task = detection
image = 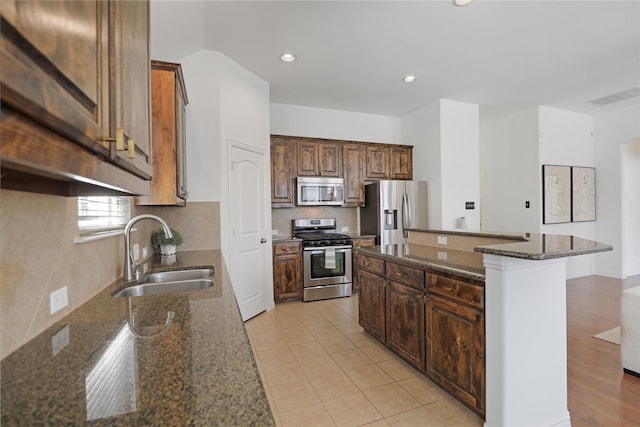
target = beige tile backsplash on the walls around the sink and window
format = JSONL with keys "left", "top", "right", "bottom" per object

{"left": 0, "top": 190, "right": 220, "bottom": 359}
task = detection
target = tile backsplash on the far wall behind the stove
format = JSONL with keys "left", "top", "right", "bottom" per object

{"left": 271, "top": 206, "right": 358, "bottom": 235}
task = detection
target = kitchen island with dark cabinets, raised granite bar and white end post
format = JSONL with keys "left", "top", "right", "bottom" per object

{"left": 359, "top": 230, "right": 612, "bottom": 426}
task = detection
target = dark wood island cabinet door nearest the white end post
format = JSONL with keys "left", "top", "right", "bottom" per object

{"left": 425, "top": 296, "right": 485, "bottom": 413}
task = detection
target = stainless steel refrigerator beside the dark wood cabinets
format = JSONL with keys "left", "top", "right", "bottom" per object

{"left": 360, "top": 181, "right": 427, "bottom": 245}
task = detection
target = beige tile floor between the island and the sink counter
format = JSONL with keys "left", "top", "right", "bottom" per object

{"left": 246, "top": 295, "right": 482, "bottom": 427}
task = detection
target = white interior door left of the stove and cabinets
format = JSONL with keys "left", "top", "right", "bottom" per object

{"left": 229, "top": 144, "right": 270, "bottom": 320}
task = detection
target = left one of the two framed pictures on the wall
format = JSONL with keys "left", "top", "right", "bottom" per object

{"left": 542, "top": 165, "right": 572, "bottom": 224}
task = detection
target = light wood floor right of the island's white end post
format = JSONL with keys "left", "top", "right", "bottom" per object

{"left": 567, "top": 275, "right": 640, "bottom": 427}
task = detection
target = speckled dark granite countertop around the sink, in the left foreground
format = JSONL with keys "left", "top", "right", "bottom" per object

{"left": 1, "top": 250, "right": 274, "bottom": 426}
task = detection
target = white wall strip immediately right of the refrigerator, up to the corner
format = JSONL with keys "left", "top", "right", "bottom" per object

{"left": 402, "top": 103, "right": 442, "bottom": 228}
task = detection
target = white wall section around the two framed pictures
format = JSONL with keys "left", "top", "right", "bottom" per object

{"left": 538, "top": 107, "right": 596, "bottom": 278}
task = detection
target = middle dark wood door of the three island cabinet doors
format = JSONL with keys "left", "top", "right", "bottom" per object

{"left": 386, "top": 282, "right": 425, "bottom": 370}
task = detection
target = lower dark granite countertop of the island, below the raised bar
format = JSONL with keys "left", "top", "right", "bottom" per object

{"left": 358, "top": 244, "right": 485, "bottom": 282}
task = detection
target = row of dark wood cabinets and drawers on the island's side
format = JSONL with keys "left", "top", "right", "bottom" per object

{"left": 358, "top": 252, "right": 485, "bottom": 416}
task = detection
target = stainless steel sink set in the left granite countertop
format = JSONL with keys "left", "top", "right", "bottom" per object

{"left": 111, "top": 267, "right": 213, "bottom": 297}
